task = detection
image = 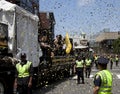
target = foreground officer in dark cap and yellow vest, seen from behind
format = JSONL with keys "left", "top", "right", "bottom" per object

{"left": 93, "top": 57, "right": 113, "bottom": 94}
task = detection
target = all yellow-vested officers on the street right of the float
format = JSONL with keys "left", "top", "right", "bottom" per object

{"left": 74, "top": 54, "right": 120, "bottom": 94}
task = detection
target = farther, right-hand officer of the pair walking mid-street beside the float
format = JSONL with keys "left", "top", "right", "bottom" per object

{"left": 85, "top": 56, "right": 92, "bottom": 78}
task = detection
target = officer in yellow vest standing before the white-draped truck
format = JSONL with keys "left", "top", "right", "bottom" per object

{"left": 14, "top": 53, "right": 33, "bottom": 94}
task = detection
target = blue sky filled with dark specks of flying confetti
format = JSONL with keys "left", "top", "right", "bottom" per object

{"left": 40, "top": 0, "right": 120, "bottom": 35}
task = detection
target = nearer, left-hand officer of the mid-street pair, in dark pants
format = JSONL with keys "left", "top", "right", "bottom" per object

{"left": 75, "top": 57, "right": 84, "bottom": 84}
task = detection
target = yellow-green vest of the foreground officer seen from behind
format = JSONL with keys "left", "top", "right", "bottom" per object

{"left": 96, "top": 70, "right": 112, "bottom": 94}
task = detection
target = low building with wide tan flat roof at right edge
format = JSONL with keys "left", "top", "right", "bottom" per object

{"left": 95, "top": 32, "right": 120, "bottom": 53}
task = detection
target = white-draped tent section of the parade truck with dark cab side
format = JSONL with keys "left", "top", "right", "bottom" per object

{"left": 0, "top": 0, "right": 40, "bottom": 94}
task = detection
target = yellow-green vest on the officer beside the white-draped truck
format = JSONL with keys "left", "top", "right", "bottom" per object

{"left": 16, "top": 61, "right": 32, "bottom": 78}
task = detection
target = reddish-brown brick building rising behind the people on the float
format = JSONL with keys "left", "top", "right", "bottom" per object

{"left": 39, "top": 12, "right": 55, "bottom": 41}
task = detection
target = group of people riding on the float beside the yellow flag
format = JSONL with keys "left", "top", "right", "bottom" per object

{"left": 39, "top": 35, "right": 66, "bottom": 63}
